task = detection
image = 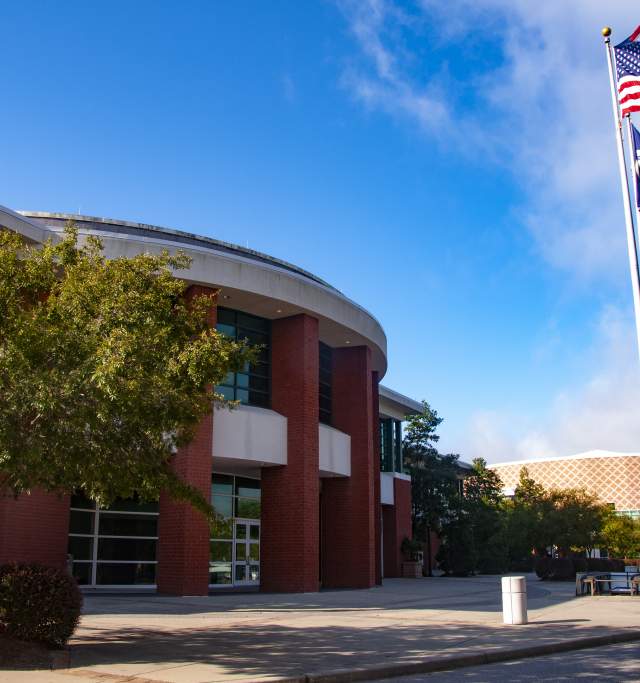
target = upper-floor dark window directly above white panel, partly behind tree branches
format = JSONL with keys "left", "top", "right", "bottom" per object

{"left": 216, "top": 307, "right": 271, "bottom": 407}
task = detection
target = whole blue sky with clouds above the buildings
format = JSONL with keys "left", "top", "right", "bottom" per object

{"left": 0, "top": 0, "right": 640, "bottom": 461}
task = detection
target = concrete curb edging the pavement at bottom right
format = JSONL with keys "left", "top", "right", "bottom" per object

{"left": 296, "top": 631, "right": 640, "bottom": 683}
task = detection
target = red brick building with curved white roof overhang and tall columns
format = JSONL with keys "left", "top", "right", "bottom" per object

{"left": 0, "top": 207, "right": 421, "bottom": 595}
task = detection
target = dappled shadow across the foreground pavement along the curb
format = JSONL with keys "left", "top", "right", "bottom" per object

{"left": 65, "top": 622, "right": 632, "bottom": 680}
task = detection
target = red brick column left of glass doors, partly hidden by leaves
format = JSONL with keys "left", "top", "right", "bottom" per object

{"left": 157, "top": 285, "right": 216, "bottom": 595}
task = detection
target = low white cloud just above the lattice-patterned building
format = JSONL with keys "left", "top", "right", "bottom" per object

{"left": 462, "top": 309, "right": 640, "bottom": 462}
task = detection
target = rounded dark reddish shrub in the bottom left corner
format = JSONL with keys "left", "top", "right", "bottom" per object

{"left": 0, "top": 564, "right": 82, "bottom": 647}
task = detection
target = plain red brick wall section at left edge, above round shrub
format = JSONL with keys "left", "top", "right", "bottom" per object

{"left": 0, "top": 490, "right": 69, "bottom": 569}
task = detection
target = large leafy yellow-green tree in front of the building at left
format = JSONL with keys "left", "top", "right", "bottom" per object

{"left": 0, "top": 225, "right": 253, "bottom": 516}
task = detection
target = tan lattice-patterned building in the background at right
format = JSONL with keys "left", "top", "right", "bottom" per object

{"left": 491, "top": 450, "right": 640, "bottom": 517}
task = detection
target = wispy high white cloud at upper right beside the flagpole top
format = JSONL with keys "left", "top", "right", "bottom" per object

{"left": 338, "top": 0, "right": 639, "bottom": 280}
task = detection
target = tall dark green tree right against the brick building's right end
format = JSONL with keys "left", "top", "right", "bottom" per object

{"left": 403, "top": 401, "right": 459, "bottom": 576}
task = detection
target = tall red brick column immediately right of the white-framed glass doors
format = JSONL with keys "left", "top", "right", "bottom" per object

{"left": 260, "top": 315, "right": 319, "bottom": 592}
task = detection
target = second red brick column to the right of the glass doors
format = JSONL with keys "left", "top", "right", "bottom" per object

{"left": 322, "top": 347, "right": 378, "bottom": 588}
